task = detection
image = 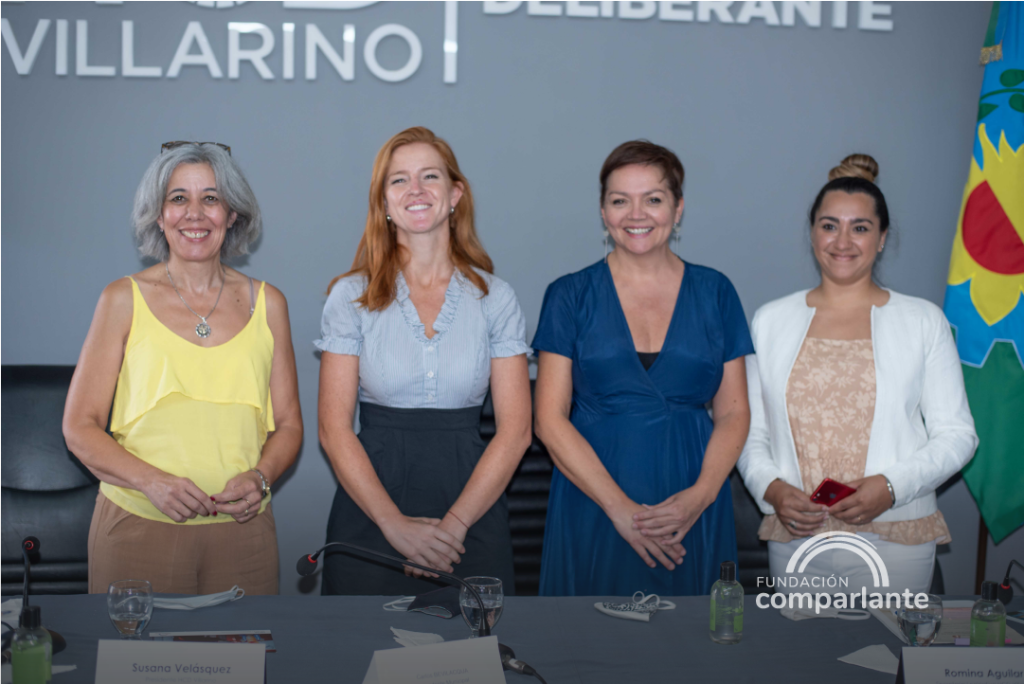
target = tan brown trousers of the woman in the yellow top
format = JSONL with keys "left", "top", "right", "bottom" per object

{"left": 89, "top": 493, "right": 278, "bottom": 595}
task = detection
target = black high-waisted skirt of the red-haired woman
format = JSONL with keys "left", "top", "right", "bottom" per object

{"left": 322, "top": 402, "right": 515, "bottom": 596}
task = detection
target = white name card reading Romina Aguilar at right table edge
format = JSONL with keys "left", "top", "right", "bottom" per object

{"left": 896, "top": 646, "right": 1024, "bottom": 684}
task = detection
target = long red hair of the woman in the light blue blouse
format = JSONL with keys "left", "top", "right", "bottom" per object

{"left": 328, "top": 126, "right": 495, "bottom": 311}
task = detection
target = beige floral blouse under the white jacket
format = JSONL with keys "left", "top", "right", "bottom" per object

{"left": 758, "top": 337, "right": 951, "bottom": 545}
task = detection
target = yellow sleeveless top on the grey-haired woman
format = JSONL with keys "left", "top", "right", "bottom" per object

{"left": 99, "top": 277, "right": 274, "bottom": 525}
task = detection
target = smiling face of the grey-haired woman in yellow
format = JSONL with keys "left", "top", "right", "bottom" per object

{"left": 157, "top": 164, "right": 238, "bottom": 261}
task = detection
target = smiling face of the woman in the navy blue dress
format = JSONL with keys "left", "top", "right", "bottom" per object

{"left": 601, "top": 164, "right": 683, "bottom": 255}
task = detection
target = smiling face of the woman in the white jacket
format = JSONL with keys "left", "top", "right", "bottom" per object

{"left": 811, "top": 190, "right": 886, "bottom": 285}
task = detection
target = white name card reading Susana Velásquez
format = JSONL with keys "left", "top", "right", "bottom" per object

{"left": 96, "top": 640, "right": 266, "bottom": 684}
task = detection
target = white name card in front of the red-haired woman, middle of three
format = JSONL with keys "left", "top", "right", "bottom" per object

{"left": 362, "top": 637, "right": 505, "bottom": 684}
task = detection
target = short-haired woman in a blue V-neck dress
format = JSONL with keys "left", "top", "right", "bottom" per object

{"left": 532, "top": 140, "right": 754, "bottom": 596}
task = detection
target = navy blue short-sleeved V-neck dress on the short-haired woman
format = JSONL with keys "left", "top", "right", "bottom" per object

{"left": 532, "top": 261, "right": 754, "bottom": 596}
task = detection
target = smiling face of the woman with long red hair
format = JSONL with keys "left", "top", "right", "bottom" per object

{"left": 384, "top": 142, "right": 462, "bottom": 234}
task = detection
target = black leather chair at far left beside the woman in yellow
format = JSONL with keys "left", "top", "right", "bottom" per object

{"left": 0, "top": 366, "right": 99, "bottom": 596}
